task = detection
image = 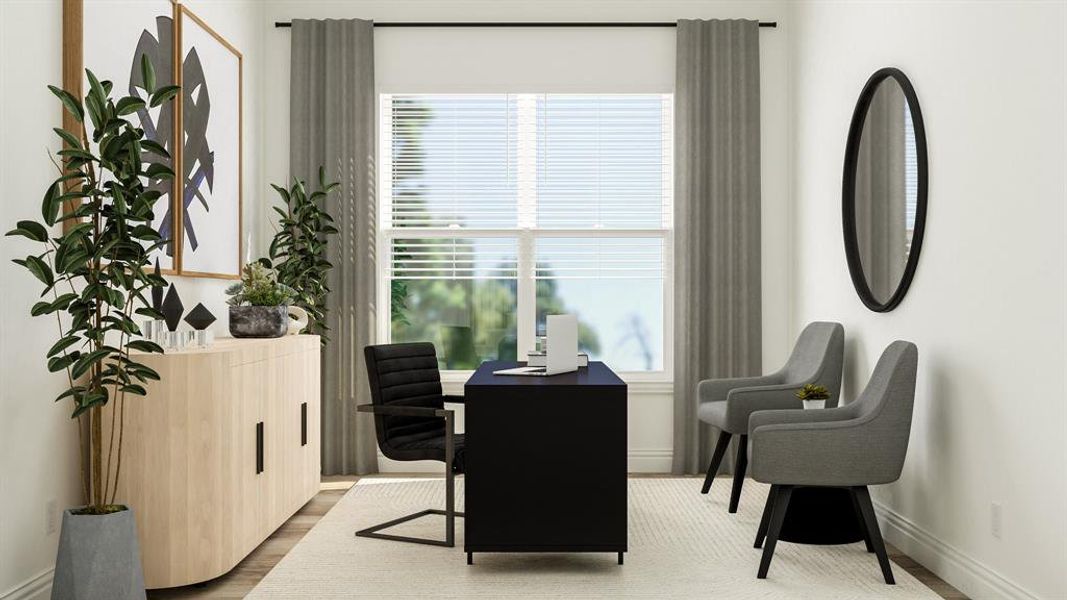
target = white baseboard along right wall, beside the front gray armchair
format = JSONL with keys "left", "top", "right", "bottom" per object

{"left": 874, "top": 502, "right": 1038, "bottom": 600}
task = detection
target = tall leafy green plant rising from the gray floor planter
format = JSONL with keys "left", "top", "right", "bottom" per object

{"left": 7, "top": 58, "right": 178, "bottom": 514}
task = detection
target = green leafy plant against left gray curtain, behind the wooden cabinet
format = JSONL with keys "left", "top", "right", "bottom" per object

{"left": 270, "top": 167, "right": 340, "bottom": 344}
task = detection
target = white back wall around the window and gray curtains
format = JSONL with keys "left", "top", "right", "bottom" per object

{"left": 262, "top": 0, "right": 792, "bottom": 472}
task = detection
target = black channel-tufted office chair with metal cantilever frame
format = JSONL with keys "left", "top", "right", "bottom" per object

{"left": 355, "top": 343, "right": 463, "bottom": 548}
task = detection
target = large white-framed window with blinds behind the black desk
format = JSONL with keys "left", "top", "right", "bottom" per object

{"left": 379, "top": 94, "right": 673, "bottom": 373}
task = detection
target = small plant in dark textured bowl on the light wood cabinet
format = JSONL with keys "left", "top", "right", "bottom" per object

{"left": 226, "top": 263, "right": 297, "bottom": 337}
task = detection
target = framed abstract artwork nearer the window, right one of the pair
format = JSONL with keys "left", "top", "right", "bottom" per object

{"left": 175, "top": 4, "right": 242, "bottom": 279}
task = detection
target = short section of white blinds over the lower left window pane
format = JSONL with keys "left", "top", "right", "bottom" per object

{"left": 389, "top": 237, "right": 519, "bottom": 280}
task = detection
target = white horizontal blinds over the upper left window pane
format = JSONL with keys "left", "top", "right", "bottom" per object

{"left": 387, "top": 94, "right": 517, "bottom": 228}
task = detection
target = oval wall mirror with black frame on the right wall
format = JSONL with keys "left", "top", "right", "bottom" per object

{"left": 842, "top": 68, "right": 927, "bottom": 313}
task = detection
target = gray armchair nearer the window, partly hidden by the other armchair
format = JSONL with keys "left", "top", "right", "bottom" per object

{"left": 697, "top": 321, "right": 845, "bottom": 512}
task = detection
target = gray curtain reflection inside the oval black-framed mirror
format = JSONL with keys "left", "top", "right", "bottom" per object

{"left": 856, "top": 79, "right": 908, "bottom": 302}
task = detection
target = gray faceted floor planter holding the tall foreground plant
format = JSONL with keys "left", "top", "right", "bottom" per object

{"left": 52, "top": 508, "right": 145, "bottom": 600}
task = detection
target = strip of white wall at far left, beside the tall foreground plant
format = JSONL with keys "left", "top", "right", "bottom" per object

{"left": 0, "top": 5, "right": 80, "bottom": 597}
